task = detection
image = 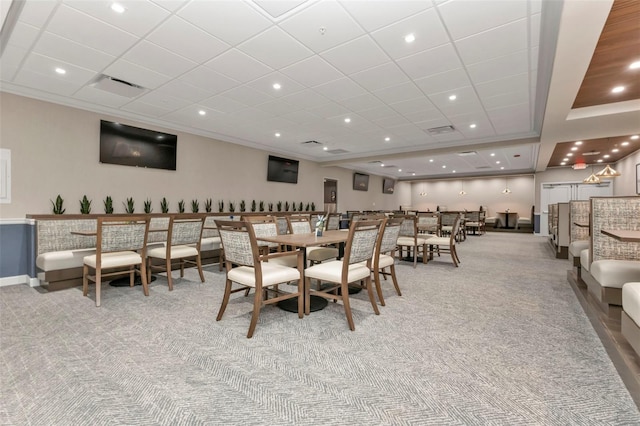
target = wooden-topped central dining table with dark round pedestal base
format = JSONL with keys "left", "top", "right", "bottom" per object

{"left": 260, "top": 229, "right": 349, "bottom": 313}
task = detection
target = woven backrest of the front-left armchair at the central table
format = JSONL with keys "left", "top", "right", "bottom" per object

{"left": 216, "top": 220, "right": 258, "bottom": 269}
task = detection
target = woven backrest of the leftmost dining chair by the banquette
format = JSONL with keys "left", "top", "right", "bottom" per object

{"left": 96, "top": 216, "right": 150, "bottom": 253}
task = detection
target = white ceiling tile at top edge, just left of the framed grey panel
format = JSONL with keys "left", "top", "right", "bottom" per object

{"left": 177, "top": 1, "right": 272, "bottom": 46}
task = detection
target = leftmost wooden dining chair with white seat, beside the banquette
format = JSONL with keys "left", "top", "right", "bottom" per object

{"left": 82, "top": 216, "right": 150, "bottom": 306}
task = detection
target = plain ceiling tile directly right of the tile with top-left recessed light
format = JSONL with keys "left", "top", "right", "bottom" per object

{"left": 147, "top": 16, "right": 230, "bottom": 63}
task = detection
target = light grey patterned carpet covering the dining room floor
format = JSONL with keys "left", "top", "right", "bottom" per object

{"left": 0, "top": 233, "right": 640, "bottom": 425}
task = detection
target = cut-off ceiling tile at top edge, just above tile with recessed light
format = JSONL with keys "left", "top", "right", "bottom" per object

{"left": 340, "top": 0, "right": 432, "bottom": 31}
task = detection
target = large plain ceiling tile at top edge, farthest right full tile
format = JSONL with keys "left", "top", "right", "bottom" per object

{"left": 438, "top": 0, "right": 528, "bottom": 40}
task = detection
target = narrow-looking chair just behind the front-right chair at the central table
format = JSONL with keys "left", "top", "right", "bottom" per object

{"left": 371, "top": 217, "right": 404, "bottom": 306}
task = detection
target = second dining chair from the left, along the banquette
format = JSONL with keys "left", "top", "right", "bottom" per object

{"left": 147, "top": 213, "right": 205, "bottom": 291}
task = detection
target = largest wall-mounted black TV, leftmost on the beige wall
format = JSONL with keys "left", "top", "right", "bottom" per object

{"left": 100, "top": 120, "right": 178, "bottom": 170}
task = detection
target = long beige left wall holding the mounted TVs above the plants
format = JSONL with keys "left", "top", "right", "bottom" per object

{"left": 0, "top": 93, "right": 410, "bottom": 218}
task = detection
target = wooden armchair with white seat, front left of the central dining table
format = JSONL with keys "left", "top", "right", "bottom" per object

{"left": 216, "top": 221, "right": 304, "bottom": 338}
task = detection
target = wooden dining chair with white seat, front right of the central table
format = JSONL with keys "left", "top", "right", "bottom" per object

{"left": 304, "top": 219, "right": 384, "bottom": 330}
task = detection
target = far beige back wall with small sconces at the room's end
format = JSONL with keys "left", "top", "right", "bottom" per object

{"left": 411, "top": 175, "right": 534, "bottom": 217}
